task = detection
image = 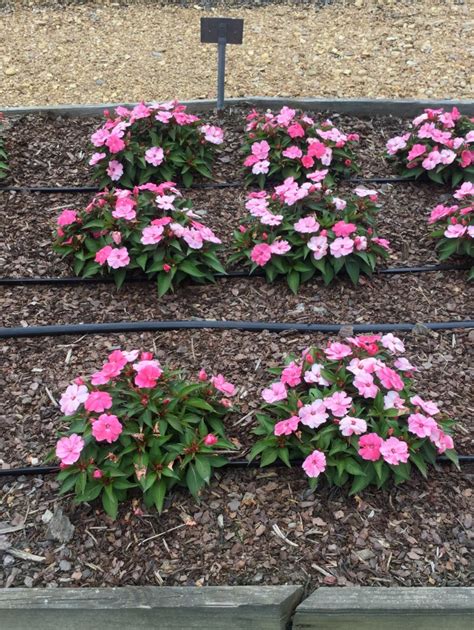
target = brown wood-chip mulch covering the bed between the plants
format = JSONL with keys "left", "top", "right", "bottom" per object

{"left": 0, "top": 110, "right": 474, "bottom": 589}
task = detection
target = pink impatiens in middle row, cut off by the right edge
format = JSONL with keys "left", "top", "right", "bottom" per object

{"left": 428, "top": 182, "right": 474, "bottom": 278}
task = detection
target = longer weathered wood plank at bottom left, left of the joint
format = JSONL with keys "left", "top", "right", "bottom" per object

{"left": 0, "top": 586, "right": 302, "bottom": 630}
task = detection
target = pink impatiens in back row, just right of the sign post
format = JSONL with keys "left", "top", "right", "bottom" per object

{"left": 242, "top": 107, "right": 359, "bottom": 188}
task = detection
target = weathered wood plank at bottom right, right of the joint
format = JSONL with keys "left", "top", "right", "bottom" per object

{"left": 293, "top": 587, "right": 474, "bottom": 630}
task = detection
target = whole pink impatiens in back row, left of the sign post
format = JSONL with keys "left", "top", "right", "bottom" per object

{"left": 89, "top": 101, "right": 224, "bottom": 188}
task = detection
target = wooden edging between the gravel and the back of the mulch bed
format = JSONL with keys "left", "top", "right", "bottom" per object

{"left": 0, "top": 96, "right": 474, "bottom": 117}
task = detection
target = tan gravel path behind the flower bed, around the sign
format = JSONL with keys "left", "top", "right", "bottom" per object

{"left": 0, "top": 0, "right": 474, "bottom": 108}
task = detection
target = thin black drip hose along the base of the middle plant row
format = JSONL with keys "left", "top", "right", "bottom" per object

{"left": 0, "top": 264, "right": 470, "bottom": 286}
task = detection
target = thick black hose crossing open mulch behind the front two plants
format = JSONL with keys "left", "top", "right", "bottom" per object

{"left": 0, "top": 319, "right": 474, "bottom": 339}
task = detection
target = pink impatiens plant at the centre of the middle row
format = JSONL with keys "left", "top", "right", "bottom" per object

{"left": 230, "top": 177, "right": 389, "bottom": 293}
